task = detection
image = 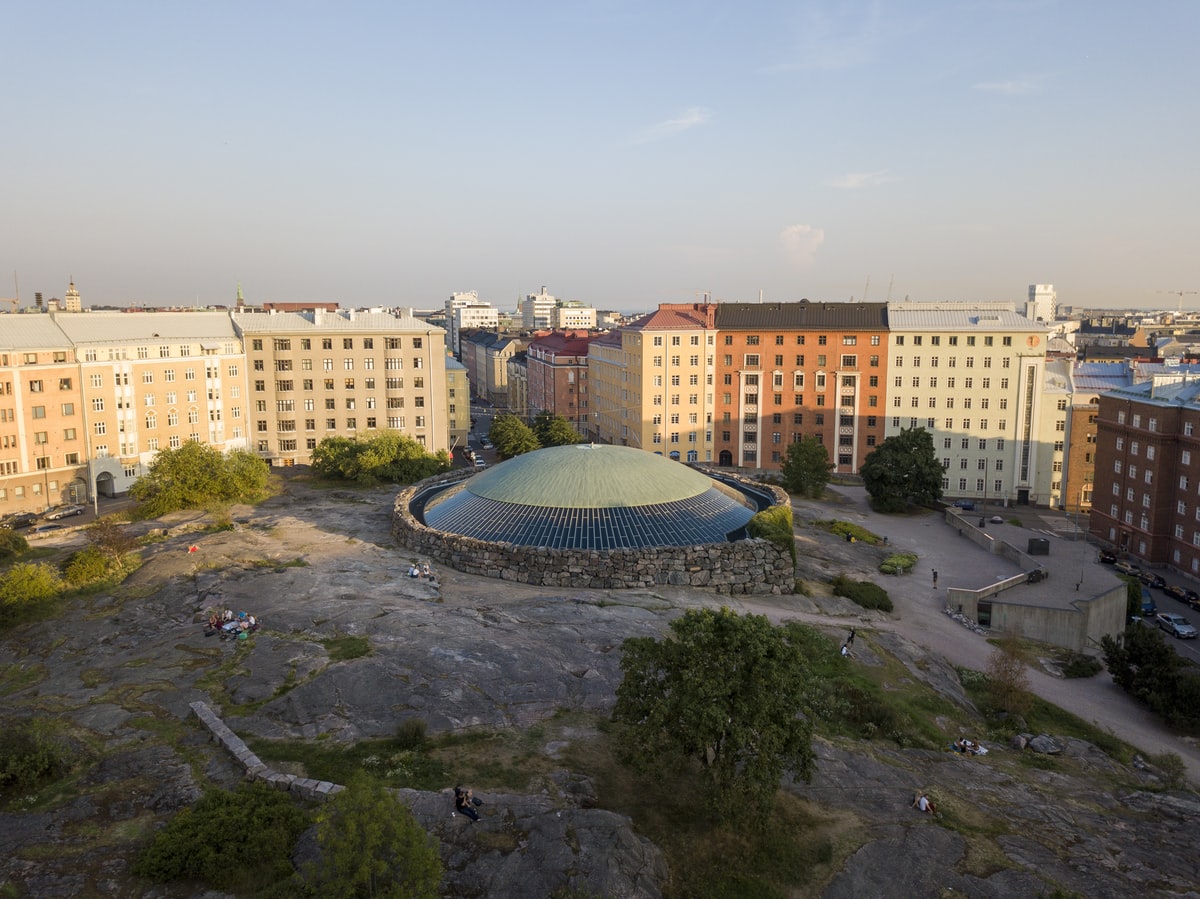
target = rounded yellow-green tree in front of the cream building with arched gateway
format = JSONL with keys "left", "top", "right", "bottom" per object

{"left": 130, "top": 440, "right": 269, "bottom": 517}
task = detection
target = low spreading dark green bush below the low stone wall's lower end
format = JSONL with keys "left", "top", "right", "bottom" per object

{"left": 133, "top": 784, "right": 308, "bottom": 892}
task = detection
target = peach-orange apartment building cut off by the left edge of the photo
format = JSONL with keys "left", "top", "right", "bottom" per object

{"left": 0, "top": 314, "right": 91, "bottom": 515}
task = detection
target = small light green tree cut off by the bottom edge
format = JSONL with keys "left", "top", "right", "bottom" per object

{"left": 306, "top": 771, "right": 442, "bottom": 899}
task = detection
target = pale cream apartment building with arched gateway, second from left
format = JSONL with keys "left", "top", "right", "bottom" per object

{"left": 54, "top": 311, "right": 248, "bottom": 496}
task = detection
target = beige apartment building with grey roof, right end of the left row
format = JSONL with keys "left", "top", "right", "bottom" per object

{"left": 233, "top": 310, "right": 448, "bottom": 466}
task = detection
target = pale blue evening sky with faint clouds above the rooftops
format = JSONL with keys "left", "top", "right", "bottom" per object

{"left": 0, "top": 0, "right": 1200, "bottom": 311}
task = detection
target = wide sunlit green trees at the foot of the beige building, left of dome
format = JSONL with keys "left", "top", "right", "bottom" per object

{"left": 312, "top": 431, "right": 450, "bottom": 486}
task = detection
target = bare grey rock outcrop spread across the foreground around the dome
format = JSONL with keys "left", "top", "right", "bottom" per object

{"left": 0, "top": 472, "right": 1200, "bottom": 899}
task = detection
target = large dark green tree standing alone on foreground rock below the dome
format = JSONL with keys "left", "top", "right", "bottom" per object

{"left": 613, "top": 609, "right": 814, "bottom": 821}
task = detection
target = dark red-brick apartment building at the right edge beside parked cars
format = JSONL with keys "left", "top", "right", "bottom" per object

{"left": 1090, "top": 373, "right": 1200, "bottom": 576}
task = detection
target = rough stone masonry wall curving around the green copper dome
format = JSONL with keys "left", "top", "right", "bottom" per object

{"left": 391, "top": 472, "right": 796, "bottom": 594}
